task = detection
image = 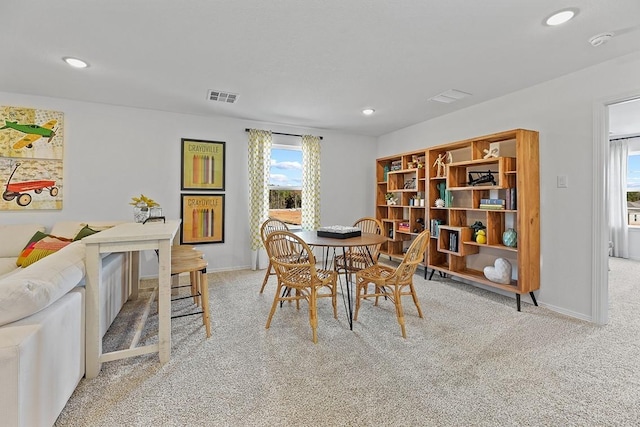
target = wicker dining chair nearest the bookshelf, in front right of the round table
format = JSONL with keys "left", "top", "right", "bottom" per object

{"left": 353, "top": 230, "right": 429, "bottom": 338}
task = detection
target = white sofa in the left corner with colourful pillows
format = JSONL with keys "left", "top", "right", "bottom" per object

{"left": 0, "top": 222, "right": 129, "bottom": 427}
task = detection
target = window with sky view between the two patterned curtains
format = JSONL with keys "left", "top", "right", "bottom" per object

{"left": 269, "top": 144, "right": 302, "bottom": 228}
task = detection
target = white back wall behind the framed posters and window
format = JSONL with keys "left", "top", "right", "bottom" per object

{"left": 0, "top": 92, "right": 376, "bottom": 275}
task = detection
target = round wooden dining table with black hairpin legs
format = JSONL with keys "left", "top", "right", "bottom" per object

{"left": 293, "top": 231, "right": 387, "bottom": 330}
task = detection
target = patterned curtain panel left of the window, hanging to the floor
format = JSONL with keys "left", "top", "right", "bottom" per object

{"left": 249, "top": 129, "right": 272, "bottom": 270}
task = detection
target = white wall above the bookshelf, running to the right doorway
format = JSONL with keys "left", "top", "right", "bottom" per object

{"left": 378, "top": 53, "right": 640, "bottom": 320}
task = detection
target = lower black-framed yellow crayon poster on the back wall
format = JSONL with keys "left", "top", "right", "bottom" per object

{"left": 180, "top": 194, "right": 224, "bottom": 244}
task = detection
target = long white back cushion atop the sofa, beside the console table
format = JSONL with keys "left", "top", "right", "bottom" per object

{"left": 0, "top": 242, "right": 85, "bottom": 326}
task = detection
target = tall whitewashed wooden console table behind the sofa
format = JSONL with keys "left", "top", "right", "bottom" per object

{"left": 82, "top": 220, "right": 180, "bottom": 378}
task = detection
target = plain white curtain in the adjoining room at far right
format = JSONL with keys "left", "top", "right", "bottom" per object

{"left": 607, "top": 139, "right": 629, "bottom": 258}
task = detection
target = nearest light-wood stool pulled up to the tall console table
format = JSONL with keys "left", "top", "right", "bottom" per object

{"left": 171, "top": 249, "right": 211, "bottom": 338}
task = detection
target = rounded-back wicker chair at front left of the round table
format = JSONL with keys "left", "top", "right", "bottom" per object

{"left": 265, "top": 231, "right": 338, "bottom": 343}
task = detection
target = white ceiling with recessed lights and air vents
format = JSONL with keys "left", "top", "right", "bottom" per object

{"left": 0, "top": 0, "right": 640, "bottom": 136}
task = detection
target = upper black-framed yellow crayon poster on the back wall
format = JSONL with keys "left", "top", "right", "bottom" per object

{"left": 181, "top": 138, "right": 225, "bottom": 191}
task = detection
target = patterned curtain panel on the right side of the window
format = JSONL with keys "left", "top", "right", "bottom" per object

{"left": 302, "top": 135, "right": 320, "bottom": 230}
